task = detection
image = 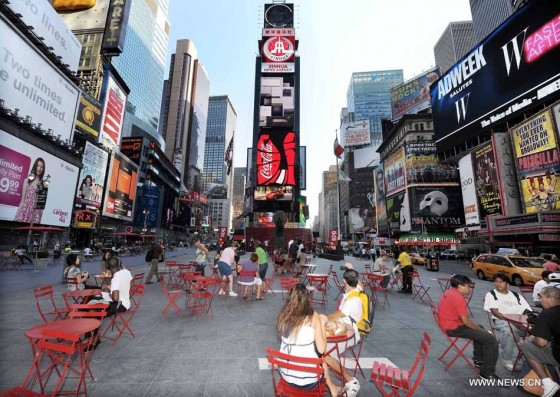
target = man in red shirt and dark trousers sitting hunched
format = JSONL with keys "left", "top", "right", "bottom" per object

{"left": 438, "top": 274, "right": 500, "bottom": 379}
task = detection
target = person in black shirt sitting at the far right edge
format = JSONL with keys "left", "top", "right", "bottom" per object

{"left": 521, "top": 287, "right": 560, "bottom": 397}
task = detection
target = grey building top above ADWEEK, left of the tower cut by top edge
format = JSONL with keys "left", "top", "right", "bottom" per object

{"left": 434, "top": 21, "right": 477, "bottom": 74}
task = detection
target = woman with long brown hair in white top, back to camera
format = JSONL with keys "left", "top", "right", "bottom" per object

{"left": 276, "top": 283, "right": 340, "bottom": 396}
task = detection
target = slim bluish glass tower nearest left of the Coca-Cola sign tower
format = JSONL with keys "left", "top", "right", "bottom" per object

{"left": 202, "top": 95, "right": 236, "bottom": 226}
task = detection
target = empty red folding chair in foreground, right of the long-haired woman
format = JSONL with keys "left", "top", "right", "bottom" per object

{"left": 370, "top": 332, "right": 432, "bottom": 397}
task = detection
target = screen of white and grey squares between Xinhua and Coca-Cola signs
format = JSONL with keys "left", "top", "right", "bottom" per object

{"left": 259, "top": 75, "right": 295, "bottom": 128}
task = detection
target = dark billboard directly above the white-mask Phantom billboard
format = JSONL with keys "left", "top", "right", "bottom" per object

{"left": 405, "top": 141, "right": 458, "bottom": 184}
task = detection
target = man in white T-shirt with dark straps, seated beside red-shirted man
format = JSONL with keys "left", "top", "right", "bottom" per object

{"left": 484, "top": 273, "right": 531, "bottom": 371}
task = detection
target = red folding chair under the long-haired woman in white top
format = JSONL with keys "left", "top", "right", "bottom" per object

{"left": 266, "top": 348, "right": 327, "bottom": 397}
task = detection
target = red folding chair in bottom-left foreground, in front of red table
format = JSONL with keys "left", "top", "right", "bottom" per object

{"left": 2, "top": 329, "right": 83, "bottom": 397}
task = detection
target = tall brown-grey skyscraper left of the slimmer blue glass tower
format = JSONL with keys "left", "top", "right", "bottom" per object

{"left": 162, "top": 40, "right": 210, "bottom": 193}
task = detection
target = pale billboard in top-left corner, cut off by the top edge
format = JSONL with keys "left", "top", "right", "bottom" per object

{"left": 6, "top": 0, "right": 82, "bottom": 72}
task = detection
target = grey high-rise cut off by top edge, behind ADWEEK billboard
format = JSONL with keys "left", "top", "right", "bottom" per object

{"left": 470, "top": 0, "right": 514, "bottom": 43}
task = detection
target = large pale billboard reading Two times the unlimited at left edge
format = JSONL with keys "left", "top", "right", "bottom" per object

{"left": 0, "top": 20, "right": 80, "bottom": 142}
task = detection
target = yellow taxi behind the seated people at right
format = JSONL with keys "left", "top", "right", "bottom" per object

{"left": 473, "top": 254, "right": 543, "bottom": 287}
